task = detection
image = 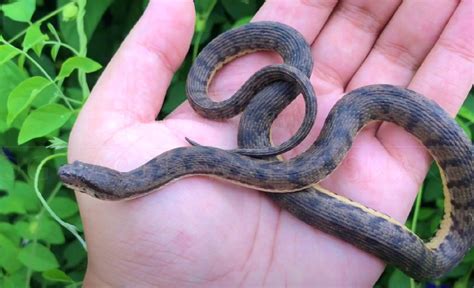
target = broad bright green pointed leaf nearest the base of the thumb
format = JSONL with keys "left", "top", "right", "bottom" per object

{"left": 18, "top": 103, "right": 72, "bottom": 145}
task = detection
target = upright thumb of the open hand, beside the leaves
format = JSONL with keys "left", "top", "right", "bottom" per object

{"left": 75, "top": 0, "right": 194, "bottom": 142}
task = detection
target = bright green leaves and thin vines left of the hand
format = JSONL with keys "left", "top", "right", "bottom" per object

{"left": 0, "top": 0, "right": 105, "bottom": 287}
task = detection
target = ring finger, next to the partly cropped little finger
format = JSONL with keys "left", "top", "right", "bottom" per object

{"left": 347, "top": 1, "right": 456, "bottom": 91}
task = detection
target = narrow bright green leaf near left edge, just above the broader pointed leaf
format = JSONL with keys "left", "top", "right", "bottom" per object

{"left": 7, "top": 76, "right": 51, "bottom": 126}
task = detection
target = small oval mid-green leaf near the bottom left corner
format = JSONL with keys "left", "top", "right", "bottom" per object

{"left": 18, "top": 243, "right": 59, "bottom": 272}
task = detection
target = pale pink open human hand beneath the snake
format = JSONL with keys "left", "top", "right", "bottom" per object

{"left": 69, "top": 0, "right": 473, "bottom": 287}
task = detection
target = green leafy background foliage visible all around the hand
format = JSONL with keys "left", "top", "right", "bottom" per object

{"left": 0, "top": 0, "right": 474, "bottom": 288}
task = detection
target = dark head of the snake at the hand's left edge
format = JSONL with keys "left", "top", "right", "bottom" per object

{"left": 58, "top": 161, "right": 121, "bottom": 200}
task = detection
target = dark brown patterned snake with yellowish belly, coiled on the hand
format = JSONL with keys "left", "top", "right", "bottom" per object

{"left": 58, "top": 21, "right": 474, "bottom": 281}
